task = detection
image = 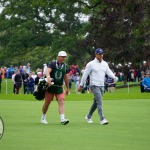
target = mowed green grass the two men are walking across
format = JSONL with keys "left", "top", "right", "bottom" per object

{"left": 0, "top": 81, "right": 150, "bottom": 150}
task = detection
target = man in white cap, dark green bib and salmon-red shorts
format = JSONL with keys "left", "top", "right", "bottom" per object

{"left": 41, "top": 51, "right": 69, "bottom": 125}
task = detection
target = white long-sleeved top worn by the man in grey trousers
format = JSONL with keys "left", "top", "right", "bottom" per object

{"left": 80, "top": 58, "right": 115, "bottom": 86}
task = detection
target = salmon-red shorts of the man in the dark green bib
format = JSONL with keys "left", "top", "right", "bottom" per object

{"left": 45, "top": 91, "right": 65, "bottom": 102}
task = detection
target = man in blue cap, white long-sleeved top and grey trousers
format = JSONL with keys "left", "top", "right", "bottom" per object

{"left": 78, "top": 48, "right": 118, "bottom": 125}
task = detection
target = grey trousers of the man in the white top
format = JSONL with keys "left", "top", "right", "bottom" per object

{"left": 87, "top": 85, "right": 104, "bottom": 120}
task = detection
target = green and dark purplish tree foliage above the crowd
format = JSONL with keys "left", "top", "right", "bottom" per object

{"left": 0, "top": 0, "right": 150, "bottom": 67}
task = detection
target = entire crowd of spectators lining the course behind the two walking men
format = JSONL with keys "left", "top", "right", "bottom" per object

{"left": 0, "top": 61, "right": 150, "bottom": 94}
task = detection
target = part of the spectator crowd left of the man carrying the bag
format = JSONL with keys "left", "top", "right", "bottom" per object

{"left": 0, "top": 63, "right": 44, "bottom": 94}
